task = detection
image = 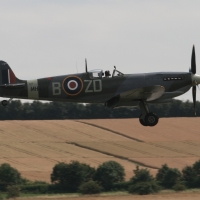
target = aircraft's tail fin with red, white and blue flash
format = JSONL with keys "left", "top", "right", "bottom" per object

{"left": 0, "top": 61, "right": 19, "bottom": 85}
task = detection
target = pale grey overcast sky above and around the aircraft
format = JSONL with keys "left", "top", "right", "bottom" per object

{"left": 0, "top": 0, "right": 200, "bottom": 101}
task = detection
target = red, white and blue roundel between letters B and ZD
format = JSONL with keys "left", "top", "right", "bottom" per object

{"left": 62, "top": 76, "right": 83, "bottom": 96}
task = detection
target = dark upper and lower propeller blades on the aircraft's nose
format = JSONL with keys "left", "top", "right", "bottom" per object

{"left": 190, "top": 45, "right": 197, "bottom": 115}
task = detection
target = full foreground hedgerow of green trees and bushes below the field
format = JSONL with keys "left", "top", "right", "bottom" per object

{"left": 0, "top": 160, "right": 200, "bottom": 199}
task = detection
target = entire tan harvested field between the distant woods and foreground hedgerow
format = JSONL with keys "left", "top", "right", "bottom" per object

{"left": 0, "top": 117, "right": 200, "bottom": 182}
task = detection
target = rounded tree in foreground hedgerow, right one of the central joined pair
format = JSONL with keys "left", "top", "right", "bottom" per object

{"left": 94, "top": 161, "right": 125, "bottom": 190}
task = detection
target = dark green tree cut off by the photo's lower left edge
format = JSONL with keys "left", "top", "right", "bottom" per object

{"left": 0, "top": 163, "right": 22, "bottom": 190}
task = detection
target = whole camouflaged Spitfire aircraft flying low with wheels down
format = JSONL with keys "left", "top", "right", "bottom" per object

{"left": 0, "top": 46, "right": 200, "bottom": 126}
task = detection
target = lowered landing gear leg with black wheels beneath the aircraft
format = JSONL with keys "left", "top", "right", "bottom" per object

{"left": 139, "top": 101, "right": 159, "bottom": 126}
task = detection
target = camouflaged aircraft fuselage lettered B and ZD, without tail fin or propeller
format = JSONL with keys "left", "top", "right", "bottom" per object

{"left": 0, "top": 72, "right": 192, "bottom": 106}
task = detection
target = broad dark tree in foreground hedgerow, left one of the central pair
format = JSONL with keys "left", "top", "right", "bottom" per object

{"left": 51, "top": 161, "right": 95, "bottom": 192}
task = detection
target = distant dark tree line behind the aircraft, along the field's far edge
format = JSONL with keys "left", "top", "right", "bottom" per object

{"left": 0, "top": 100, "right": 200, "bottom": 120}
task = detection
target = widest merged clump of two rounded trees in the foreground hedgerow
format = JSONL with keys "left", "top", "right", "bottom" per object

{"left": 51, "top": 161, "right": 125, "bottom": 194}
